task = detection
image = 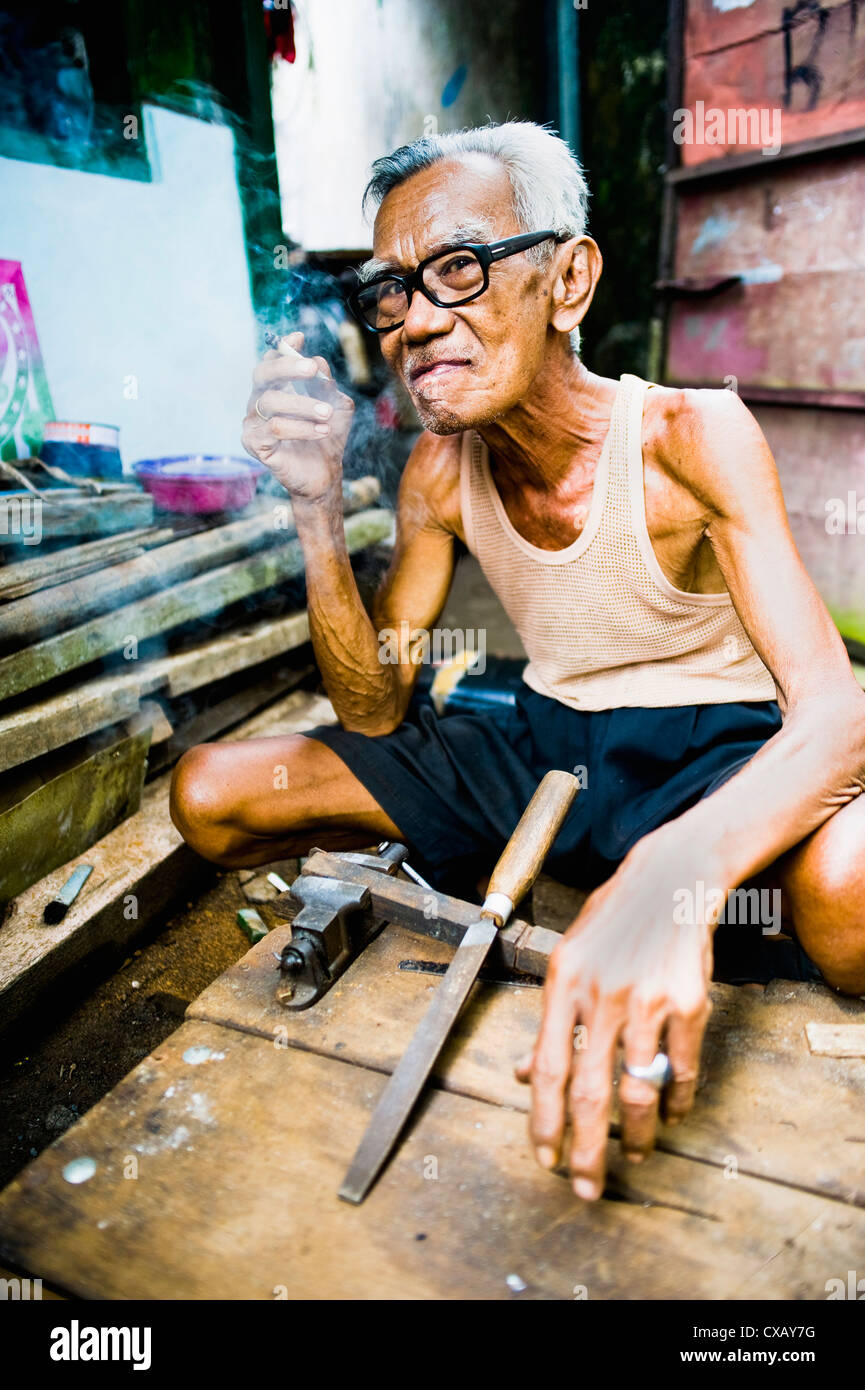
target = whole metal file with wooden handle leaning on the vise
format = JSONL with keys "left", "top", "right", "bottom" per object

{"left": 339, "top": 771, "right": 580, "bottom": 1202}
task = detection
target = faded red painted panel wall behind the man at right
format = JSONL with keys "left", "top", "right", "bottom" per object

{"left": 675, "top": 0, "right": 865, "bottom": 644}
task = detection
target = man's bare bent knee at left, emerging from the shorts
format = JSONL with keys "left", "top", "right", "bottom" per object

{"left": 171, "top": 734, "right": 402, "bottom": 867}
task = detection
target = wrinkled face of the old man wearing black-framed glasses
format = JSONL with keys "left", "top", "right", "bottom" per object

{"left": 373, "top": 154, "right": 552, "bottom": 434}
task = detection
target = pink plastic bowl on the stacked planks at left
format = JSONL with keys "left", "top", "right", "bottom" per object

{"left": 134, "top": 453, "right": 264, "bottom": 512}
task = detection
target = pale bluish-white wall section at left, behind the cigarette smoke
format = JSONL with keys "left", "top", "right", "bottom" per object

{"left": 0, "top": 107, "right": 256, "bottom": 468}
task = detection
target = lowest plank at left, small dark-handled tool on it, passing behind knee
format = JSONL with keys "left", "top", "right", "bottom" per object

{"left": 0, "top": 691, "right": 334, "bottom": 1027}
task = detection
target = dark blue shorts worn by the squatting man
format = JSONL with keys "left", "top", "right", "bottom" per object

{"left": 306, "top": 682, "right": 819, "bottom": 979}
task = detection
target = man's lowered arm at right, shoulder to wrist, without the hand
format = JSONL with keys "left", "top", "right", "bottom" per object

{"left": 650, "top": 391, "right": 865, "bottom": 872}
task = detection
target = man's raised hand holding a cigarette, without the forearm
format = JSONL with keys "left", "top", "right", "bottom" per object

{"left": 241, "top": 332, "right": 355, "bottom": 502}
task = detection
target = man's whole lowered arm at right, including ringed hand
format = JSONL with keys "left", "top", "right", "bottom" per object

{"left": 517, "top": 391, "right": 865, "bottom": 1201}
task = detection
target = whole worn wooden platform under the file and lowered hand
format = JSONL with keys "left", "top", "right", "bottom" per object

{"left": 0, "top": 927, "right": 865, "bottom": 1300}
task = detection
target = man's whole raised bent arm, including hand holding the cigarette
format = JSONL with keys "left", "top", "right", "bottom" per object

{"left": 243, "top": 334, "right": 460, "bottom": 735}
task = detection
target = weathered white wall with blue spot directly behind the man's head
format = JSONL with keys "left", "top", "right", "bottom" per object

{"left": 273, "top": 0, "right": 537, "bottom": 250}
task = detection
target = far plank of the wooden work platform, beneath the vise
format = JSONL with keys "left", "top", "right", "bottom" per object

{"left": 188, "top": 926, "right": 865, "bottom": 1205}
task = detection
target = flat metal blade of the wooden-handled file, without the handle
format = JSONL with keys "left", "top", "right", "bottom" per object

{"left": 339, "top": 917, "right": 498, "bottom": 1202}
